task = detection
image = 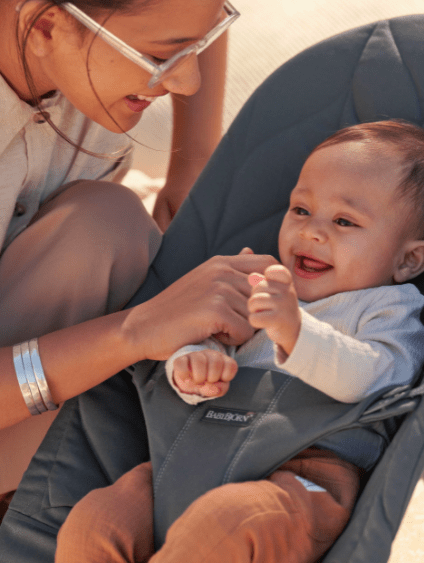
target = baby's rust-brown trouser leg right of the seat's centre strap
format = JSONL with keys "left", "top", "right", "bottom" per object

{"left": 150, "top": 454, "right": 358, "bottom": 563}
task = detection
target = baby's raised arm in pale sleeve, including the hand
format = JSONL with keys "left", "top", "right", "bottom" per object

{"left": 248, "top": 266, "right": 424, "bottom": 403}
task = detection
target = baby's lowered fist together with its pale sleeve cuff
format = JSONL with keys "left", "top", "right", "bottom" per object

{"left": 166, "top": 338, "right": 237, "bottom": 405}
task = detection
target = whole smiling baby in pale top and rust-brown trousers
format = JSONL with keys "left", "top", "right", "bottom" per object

{"left": 56, "top": 122, "right": 424, "bottom": 563}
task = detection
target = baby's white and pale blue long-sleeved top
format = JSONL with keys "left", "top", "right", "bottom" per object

{"left": 166, "top": 284, "right": 424, "bottom": 404}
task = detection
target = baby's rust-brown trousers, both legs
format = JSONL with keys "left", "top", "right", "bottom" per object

{"left": 56, "top": 448, "right": 359, "bottom": 563}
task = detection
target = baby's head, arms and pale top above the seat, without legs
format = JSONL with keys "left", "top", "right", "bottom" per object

{"left": 167, "top": 121, "right": 424, "bottom": 404}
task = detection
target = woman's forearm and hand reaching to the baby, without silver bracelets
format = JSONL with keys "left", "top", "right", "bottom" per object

{"left": 0, "top": 250, "right": 276, "bottom": 428}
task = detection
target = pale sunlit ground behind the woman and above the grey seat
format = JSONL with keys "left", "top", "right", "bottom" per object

{"left": 131, "top": 0, "right": 424, "bottom": 178}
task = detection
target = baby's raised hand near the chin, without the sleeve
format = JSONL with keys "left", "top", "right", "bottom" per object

{"left": 247, "top": 265, "right": 301, "bottom": 355}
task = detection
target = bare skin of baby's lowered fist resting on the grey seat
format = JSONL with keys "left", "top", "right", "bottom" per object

{"left": 173, "top": 350, "right": 237, "bottom": 397}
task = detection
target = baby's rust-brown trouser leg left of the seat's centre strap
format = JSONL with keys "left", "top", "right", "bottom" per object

{"left": 55, "top": 462, "right": 153, "bottom": 563}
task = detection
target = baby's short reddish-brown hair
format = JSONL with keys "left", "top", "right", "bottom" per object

{"left": 312, "top": 119, "right": 424, "bottom": 239}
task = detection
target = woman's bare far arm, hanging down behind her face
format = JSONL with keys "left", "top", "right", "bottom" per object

{"left": 153, "top": 34, "right": 227, "bottom": 231}
